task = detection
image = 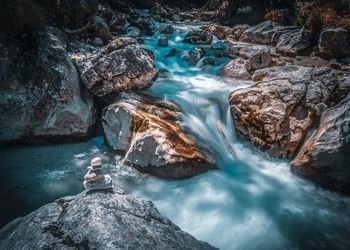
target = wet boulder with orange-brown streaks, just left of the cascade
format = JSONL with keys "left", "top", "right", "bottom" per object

{"left": 102, "top": 95, "right": 214, "bottom": 178}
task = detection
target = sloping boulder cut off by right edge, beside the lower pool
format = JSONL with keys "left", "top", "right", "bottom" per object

{"left": 291, "top": 95, "right": 350, "bottom": 193}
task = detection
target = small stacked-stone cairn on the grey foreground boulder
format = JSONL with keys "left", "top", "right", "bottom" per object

{"left": 84, "top": 157, "right": 113, "bottom": 191}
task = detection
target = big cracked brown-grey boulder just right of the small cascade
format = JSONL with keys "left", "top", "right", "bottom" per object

{"left": 229, "top": 65, "right": 339, "bottom": 158}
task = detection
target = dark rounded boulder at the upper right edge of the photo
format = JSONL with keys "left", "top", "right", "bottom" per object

{"left": 318, "top": 28, "right": 350, "bottom": 59}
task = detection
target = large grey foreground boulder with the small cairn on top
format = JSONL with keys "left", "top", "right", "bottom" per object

{"left": 0, "top": 191, "right": 215, "bottom": 250}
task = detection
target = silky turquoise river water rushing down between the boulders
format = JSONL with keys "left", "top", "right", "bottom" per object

{"left": 0, "top": 24, "right": 350, "bottom": 249}
